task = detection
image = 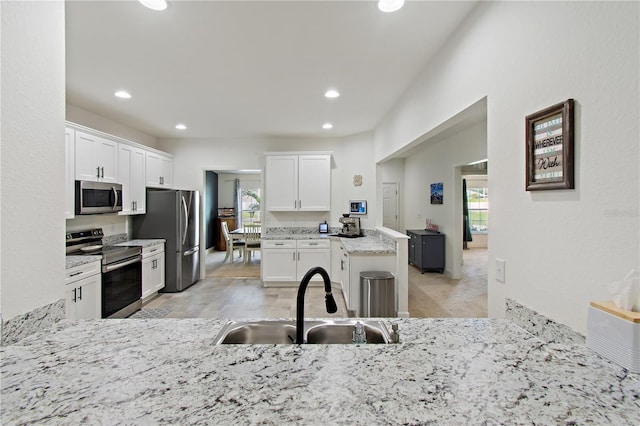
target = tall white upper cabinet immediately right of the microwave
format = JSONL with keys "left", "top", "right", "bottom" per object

{"left": 118, "top": 144, "right": 146, "bottom": 215}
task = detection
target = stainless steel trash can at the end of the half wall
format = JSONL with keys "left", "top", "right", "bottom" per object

{"left": 360, "top": 271, "right": 396, "bottom": 317}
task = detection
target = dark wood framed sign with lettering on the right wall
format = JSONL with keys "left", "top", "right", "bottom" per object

{"left": 525, "top": 99, "right": 574, "bottom": 191}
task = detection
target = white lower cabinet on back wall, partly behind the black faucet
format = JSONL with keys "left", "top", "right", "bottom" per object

{"left": 262, "top": 239, "right": 331, "bottom": 283}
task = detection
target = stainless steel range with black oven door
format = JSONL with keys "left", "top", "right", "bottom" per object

{"left": 66, "top": 228, "right": 142, "bottom": 318}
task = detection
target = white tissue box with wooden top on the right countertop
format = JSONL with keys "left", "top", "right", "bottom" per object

{"left": 587, "top": 301, "right": 640, "bottom": 373}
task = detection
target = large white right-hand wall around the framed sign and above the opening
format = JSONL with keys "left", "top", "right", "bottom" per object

{"left": 375, "top": 2, "right": 640, "bottom": 333}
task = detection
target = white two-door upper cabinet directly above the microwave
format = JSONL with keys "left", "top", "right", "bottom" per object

{"left": 75, "top": 130, "right": 118, "bottom": 183}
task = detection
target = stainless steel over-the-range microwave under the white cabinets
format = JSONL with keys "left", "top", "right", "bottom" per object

{"left": 76, "top": 180, "right": 122, "bottom": 214}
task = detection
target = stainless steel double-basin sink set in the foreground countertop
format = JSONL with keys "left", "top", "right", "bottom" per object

{"left": 215, "top": 320, "right": 391, "bottom": 345}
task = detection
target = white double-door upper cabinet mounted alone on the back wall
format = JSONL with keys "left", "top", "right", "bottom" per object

{"left": 265, "top": 154, "right": 331, "bottom": 211}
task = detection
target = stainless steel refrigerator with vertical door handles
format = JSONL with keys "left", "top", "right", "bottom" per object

{"left": 132, "top": 189, "right": 200, "bottom": 293}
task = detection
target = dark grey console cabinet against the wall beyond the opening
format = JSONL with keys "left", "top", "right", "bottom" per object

{"left": 407, "top": 229, "right": 445, "bottom": 274}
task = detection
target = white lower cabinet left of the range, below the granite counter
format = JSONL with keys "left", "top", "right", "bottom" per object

{"left": 65, "top": 261, "right": 102, "bottom": 319}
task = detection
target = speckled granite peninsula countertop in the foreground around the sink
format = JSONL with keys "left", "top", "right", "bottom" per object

{"left": 0, "top": 319, "right": 640, "bottom": 425}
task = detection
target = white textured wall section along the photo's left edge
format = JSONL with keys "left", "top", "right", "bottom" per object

{"left": 0, "top": 1, "right": 65, "bottom": 320}
